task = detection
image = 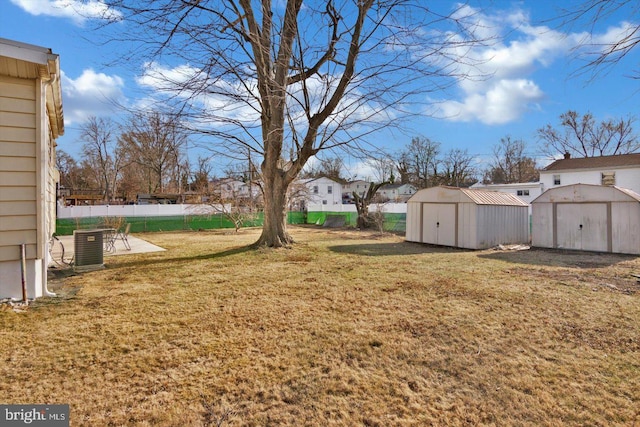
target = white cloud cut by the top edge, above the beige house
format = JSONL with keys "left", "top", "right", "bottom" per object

{"left": 11, "top": 0, "right": 122, "bottom": 25}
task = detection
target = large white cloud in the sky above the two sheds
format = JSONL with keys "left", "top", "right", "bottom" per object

{"left": 433, "top": 6, "right": 585, "bottom": 125}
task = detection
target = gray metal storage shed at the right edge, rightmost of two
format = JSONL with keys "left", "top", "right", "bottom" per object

{"left": 531, "top": 184, "right": 640, "bottom": 254}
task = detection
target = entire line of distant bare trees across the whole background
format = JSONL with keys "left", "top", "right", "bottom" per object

{"left": 57, "top": 110, "right": 640, "bottom": 203}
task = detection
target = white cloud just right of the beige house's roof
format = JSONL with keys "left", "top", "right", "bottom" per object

{"left": 61, "top": 69, "right": 125, "bottom": 125}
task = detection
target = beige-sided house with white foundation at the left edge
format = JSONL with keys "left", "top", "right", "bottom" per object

{"left": 0, "top": 39, "right": 64, "bottom": 299}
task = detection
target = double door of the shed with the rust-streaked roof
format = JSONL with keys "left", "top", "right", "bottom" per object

{"left": 422, "top": 203, "right": 456, "bottom": 246}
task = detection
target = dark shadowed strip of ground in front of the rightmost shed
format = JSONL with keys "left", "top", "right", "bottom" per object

{"left": 478, "top": 248, "right": 638, "bottom": 268}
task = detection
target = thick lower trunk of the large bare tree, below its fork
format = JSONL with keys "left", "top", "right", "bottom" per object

{"left": 254, "top": 171, "right": 293, "bottom": 248}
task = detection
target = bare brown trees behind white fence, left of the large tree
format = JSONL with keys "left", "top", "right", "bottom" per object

{"left": 57, "top": 112, "right": 212, "bottom": 203}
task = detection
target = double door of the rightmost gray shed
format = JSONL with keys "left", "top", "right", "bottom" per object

{"left": 556, "top": 203, "right": 608, "bottom": 252}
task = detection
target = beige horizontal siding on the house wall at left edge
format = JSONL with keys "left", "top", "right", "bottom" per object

{"left": 0, "top": 77, "right": 37, "bottom": 261}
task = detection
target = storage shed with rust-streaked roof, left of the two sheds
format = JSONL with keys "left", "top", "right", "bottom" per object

{"left": 406, "top": 187, "right": 529, "bottom": 249}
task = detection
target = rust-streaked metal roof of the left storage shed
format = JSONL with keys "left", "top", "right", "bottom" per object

{"left": 409, "top": 186, "right": 529, "bottom": 206}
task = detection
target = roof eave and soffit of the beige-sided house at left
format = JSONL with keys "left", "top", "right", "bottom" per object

{"left": 0, "top": 38, "right": 64, "bottom": 138}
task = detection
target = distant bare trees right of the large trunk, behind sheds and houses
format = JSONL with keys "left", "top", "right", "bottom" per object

{"left": 303, "top": 110, "right": 640, "bottom": 188}
